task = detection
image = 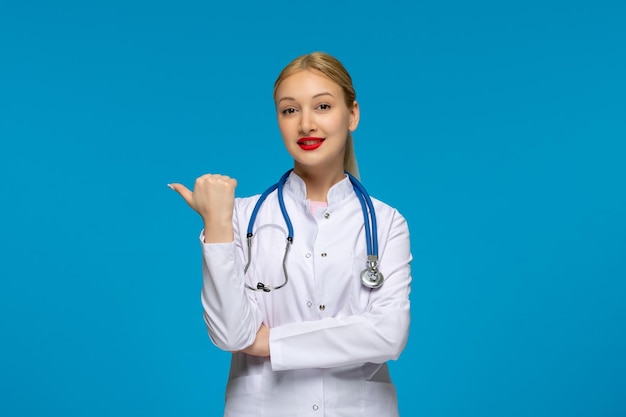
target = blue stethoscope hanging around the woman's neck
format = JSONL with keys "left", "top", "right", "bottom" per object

{"left": 244, "top": 169, "right": 384, "bottom": 292}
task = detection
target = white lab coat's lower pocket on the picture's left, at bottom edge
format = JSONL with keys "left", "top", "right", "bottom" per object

{"left": 225, "top": 375, "right": 262, "bottom": 417}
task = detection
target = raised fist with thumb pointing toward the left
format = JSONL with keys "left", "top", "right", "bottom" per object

{"left": 169, "top": 174, "right": 237, "bottom": 243}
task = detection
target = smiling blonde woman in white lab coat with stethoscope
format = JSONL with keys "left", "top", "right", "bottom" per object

{"left": 170, "top": 52, "right": 412, "bottom": 417}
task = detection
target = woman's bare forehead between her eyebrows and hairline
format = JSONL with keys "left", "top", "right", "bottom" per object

{"left": 276, "top": 69, "right": 343, "bottom": 100}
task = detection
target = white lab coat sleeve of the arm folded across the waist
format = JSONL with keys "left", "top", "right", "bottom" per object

{"left": 270, "top": 210, "right": 412, "bottom": 371}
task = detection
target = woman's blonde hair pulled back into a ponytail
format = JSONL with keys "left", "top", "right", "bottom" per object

{"left": 274, "top": 52, "right": 360, "bottom": 179}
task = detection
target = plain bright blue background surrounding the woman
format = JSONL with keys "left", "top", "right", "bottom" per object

{"left": 0, "top": 0, "right": 626, "bottom": 417}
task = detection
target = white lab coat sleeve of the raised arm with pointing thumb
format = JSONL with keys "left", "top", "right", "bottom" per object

{"left": 200, "top": 202, "right": 263, "bottom": 352}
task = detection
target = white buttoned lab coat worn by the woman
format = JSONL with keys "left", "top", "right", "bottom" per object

{"left": 201, "top": 172, "right": 412, "bottom": 417}
